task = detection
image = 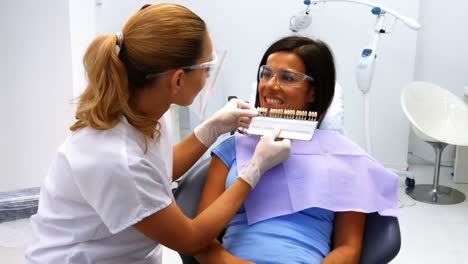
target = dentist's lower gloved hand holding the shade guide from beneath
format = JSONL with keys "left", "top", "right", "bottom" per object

{"left": 239, "top": 128, "right": 291, "bottom": 189}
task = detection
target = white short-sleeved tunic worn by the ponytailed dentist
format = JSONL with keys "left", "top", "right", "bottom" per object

{"left": 26, "top": 113, "right": 174, "bottom": 264}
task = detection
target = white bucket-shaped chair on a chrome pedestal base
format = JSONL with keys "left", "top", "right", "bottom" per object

{"left": 401, "top": 82, "right": 468, "bottom": 204}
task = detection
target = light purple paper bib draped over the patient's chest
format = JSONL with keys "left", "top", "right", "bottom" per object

{"left": 235, "top": 129, "right": 398, "bottom": 224}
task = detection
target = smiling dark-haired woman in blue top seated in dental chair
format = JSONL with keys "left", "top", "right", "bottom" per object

{"left": 192, "top": 37, "right": 396, "bottom": 263}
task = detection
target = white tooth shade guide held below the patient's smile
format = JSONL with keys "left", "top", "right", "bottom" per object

{"left": 245, "top": 107, "right": 318, "bottom": 141}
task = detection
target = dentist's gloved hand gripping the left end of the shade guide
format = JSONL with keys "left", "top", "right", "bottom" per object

{"left": 193, "top": 99, "right": 258, "bottom": 147}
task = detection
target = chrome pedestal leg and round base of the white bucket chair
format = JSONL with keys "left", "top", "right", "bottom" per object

{"left": 406, "top": 142, "right": 465, "bottom": 204}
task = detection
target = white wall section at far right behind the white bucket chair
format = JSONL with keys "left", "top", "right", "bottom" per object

{"left": 409, "top": 0, "right": 468, "bottom": 164}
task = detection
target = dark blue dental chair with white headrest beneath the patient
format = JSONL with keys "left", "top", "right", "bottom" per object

{"left": 174, "top": 84, "right": 401, "bottom": 264}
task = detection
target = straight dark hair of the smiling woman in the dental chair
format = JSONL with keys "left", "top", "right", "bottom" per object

{"left": 255, "top": 36, "right": 336, "bottom": 125}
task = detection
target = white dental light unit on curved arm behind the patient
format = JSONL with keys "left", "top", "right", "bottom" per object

{"left": 289, "top": 0, "right": 421, "bottom": 154}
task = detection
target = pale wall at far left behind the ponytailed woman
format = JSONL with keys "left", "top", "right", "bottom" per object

{"left": 0, "top": 0, "right": 73, "bottom": 191}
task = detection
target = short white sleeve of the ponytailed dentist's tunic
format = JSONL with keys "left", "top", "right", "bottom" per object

{"left": 69, "top": 141, "right": 173, "bottom": 234}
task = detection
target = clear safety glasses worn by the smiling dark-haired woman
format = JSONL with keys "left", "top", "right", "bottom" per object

{"left": 258, "top": 65, "right": 314, "bottom": 87}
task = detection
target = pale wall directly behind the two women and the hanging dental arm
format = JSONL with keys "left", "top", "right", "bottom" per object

{"left": 97, "top": 0, "right": 419, "bottom": 169}
